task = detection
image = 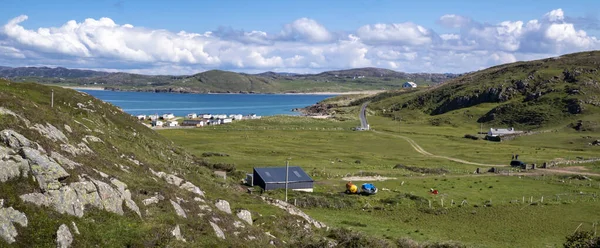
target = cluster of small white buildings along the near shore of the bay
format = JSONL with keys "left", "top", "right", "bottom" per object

{"left": 136, "top": 113, "right": 261, "bottom": 127}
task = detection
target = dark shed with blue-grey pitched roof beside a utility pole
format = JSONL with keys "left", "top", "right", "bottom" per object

{"left": 252, "top": 166, "right": 314, "bottom": 192}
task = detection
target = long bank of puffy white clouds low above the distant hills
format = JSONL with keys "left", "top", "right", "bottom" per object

{"left": 0, "top": 9, "right": 600, "bottom": 74}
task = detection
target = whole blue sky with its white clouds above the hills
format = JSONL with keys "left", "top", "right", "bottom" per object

{"left": 0, "top": 0, "right": 600, "bottom": 74}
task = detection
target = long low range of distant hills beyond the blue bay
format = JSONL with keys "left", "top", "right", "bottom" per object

{"left": 0, "top": 67, "right": 457, "bottom": 93}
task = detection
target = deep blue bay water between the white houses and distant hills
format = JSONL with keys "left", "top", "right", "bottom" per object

{"left": 81, "top": 90, "right": 335, "bottom": 116}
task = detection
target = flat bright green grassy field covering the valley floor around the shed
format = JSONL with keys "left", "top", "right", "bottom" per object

{"left": 160, "top": 109, "right": 600, "bottom": 247}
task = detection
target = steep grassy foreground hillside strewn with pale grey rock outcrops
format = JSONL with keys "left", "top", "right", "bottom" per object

{"left": 0, "top": 80, "right": 412, "bottom": 247}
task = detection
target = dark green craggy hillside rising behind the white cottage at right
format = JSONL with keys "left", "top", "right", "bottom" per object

{"left": 364, "top": 51, "right": 600, "bottom": 129}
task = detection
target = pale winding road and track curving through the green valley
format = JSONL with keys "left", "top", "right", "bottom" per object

{"left": 359, "top": 102, "right": 600, "bottom": 176}
